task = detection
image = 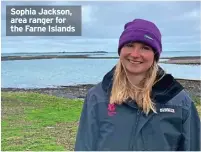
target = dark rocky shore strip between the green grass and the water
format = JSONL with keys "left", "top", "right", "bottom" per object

{"left": 1, "top": 79, "right": 201, "bottom": 99}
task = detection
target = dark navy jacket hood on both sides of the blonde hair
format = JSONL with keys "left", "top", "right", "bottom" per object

{"left": 102, "top": 66, "right": 184, "bottom": 104}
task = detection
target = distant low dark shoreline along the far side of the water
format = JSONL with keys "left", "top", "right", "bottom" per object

{"left": 1, "top": 52, "right": 201, "bottom": 65}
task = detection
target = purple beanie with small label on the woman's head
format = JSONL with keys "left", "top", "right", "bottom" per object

{"left": 118, "top": 19, "right": 162, "bottom": 61}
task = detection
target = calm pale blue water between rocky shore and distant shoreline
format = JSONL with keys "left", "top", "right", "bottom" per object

{"left": 1, "top": 59, "right": 201, "bottom": 88}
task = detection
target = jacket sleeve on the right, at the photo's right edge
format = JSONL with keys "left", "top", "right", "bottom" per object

{"left": 179, "top": 100, "right": 201, "bottom": 151}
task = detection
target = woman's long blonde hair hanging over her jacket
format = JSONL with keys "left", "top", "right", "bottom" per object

{"left": 110, "top": 60, "right": 164, "bottom": 114}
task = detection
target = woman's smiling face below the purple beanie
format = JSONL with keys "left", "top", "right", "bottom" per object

{"left": 120, "top": 42, "right": 154, "bottom": 75}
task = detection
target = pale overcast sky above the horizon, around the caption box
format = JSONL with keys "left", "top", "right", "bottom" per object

{"left": 1, "top": 1, "right": 201, "bottom": 53}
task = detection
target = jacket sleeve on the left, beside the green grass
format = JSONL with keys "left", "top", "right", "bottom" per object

{"left": 74, "top": 94, "right": 98, "bottom": 151}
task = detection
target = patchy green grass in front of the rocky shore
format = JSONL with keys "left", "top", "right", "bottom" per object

{"left": 1, "top": 92, "right": 201, "bottom": 151}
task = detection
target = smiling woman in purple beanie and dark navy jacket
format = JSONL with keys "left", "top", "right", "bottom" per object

{"left": 75, "top": 19, "right": 200, "bottom": 151}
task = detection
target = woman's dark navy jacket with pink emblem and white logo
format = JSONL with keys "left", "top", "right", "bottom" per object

{"left": 75, "top": 67, "right": 200, "bottom": 151}
